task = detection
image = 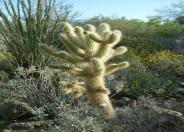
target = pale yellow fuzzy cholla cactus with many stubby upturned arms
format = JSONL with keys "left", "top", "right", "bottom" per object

{"left": 42, "top": 23, "right": 129, "bottom": 117}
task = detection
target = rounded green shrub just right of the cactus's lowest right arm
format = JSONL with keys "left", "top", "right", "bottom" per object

{"left": 118, "top": 58, "right": 157, "bottom": 96}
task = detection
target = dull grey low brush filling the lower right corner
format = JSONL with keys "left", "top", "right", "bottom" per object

{"left": 118, "top": 98, "right": 184, "bottom": 132}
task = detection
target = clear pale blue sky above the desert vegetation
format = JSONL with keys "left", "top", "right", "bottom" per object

{"left": 65, "top": 0, "right": 178, "bottom": 20}
